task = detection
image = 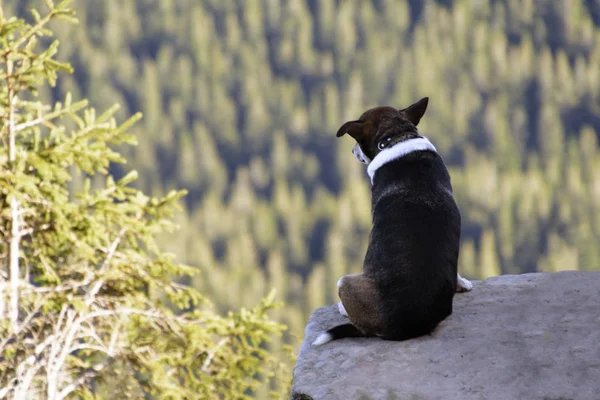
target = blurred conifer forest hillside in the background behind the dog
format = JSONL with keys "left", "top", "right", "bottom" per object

{"left": 5, "top": 0, "right": 600, "bottom": 388}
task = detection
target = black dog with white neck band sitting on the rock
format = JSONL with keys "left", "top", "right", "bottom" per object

{"left": 313, "top": 98, "right": 472, "bottom": 345}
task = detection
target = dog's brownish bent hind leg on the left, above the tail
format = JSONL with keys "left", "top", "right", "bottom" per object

{"left": 338, "top": 274, "right": 381, "bottom": 335}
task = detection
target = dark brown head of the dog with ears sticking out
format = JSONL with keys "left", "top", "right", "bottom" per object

{"left": 336, "top": 97, "right": 429, "bottom": 164}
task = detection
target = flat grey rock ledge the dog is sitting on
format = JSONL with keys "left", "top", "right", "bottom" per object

{"left": 291, "top": 271, "right": 600, "bottom": 400}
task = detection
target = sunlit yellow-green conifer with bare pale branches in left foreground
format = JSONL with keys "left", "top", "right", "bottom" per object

{"left": 0, "top": 1, "right": 289, "bottom": 399}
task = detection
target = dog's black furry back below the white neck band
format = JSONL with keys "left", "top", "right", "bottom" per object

{"left": 364, "top": 151, "right": 460, "bottom": 340}
